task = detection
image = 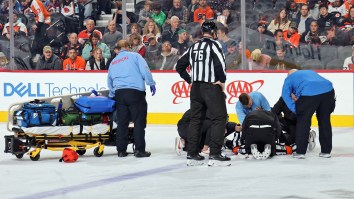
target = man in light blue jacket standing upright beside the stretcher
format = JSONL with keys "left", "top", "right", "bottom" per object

{"left": 107, "top": 40, "right": 156, "bottom": 157}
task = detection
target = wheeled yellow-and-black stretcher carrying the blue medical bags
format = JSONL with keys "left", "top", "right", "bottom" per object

{"left": 4, "top": 90, "right": 134, "bottom": 161}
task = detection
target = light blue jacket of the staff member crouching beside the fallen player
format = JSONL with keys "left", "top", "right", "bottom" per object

{"left": 236, "top": 91, "right": 270, "bottom": 124}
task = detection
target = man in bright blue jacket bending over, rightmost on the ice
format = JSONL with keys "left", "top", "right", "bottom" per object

{"left": 282, "top": 69, "right": 335, "bottom": 159}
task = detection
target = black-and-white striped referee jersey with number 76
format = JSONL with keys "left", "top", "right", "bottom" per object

{"left": 176, "top": 37, "right": 226, "bottom": 84}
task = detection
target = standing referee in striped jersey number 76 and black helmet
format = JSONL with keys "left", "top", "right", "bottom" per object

{"left": 176, "top": 21, "right": 231, "bottom": 166}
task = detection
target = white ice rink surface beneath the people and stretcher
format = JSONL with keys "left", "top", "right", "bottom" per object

{"left": 0, "top": 124, "right": 354, "bottom": 199}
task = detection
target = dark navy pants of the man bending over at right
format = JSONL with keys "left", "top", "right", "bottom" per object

{"left": 295, "top": 90, "right": 335, "bottom": 154}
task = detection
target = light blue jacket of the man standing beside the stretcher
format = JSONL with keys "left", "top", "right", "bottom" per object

{"left": 107, "top": 50, "right": 156, "bottom": 97}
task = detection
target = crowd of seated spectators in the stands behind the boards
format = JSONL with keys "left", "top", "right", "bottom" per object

{"left": 0, "top": 0, "right": 354, "bottom": 70}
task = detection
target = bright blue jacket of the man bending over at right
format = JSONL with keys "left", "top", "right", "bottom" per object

{"left": 282, "top": 70, "right": 333, "bottom": 113}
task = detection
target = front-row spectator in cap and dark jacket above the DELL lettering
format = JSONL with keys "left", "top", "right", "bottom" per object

{"left": 36, "top": 46, "right": 63, "bottom": 70}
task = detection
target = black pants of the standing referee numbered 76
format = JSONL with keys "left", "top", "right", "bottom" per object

{"left": 187, "top": 82, "right": 227, "bottom": 156}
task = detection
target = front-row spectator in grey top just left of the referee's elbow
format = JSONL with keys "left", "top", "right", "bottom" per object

{"left": 155, "top": 41, "right": 179, "bottom": 70}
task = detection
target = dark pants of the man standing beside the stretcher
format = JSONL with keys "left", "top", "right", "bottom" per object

{"left": 115, "top": 89, "right": 147, "bottom": 152}
